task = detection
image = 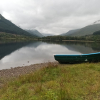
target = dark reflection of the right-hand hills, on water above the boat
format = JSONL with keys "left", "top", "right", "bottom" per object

{"left": 43, "top": 41, "right": 100, "bottom": 54}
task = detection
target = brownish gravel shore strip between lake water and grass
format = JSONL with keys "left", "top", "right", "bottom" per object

{"left": 0, "top": 62, "right": 58, "bottom": 86}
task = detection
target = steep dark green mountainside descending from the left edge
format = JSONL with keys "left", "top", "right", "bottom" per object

{"left": 0, "top": 14, "right": 36, "bottom": 37}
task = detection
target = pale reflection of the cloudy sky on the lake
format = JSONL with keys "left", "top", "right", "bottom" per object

{"left": 0, "top": 43, "right": 78, "bottom": 68}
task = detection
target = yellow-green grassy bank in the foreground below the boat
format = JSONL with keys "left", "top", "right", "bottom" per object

{"left": 0, "top": 63, "right": 100, "bottom": 100}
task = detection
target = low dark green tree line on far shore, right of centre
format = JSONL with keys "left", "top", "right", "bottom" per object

{"left": 39, "top": 35, "right": 100, "bottom": 42}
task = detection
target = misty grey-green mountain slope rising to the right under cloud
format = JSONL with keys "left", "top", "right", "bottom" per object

{"left": 60, "top": 20, "right": 100, "bottom": 36}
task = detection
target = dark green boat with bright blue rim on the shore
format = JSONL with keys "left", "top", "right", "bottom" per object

{"left": 54, "top": 52, "right": 100, "bottom": 63}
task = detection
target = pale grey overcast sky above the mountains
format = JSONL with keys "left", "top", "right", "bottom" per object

{"left": 0, "top": 0, "right": 100, "bottom": 35}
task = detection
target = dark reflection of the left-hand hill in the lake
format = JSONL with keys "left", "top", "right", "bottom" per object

{"left": 0, "top": 42, "right": 39, "bottom": 59}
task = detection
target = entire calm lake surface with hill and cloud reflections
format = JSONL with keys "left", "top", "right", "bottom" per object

{"left": 0, "top": 42, "right": 100, "bottom": 70}
